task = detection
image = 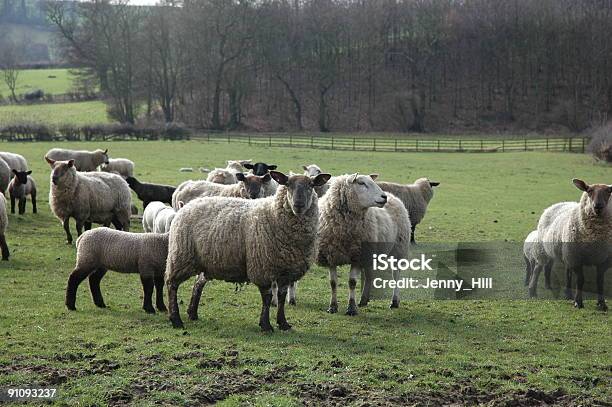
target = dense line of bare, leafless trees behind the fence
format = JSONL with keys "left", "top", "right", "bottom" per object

{"left": 46, "top": 0, "right": 612, "bottom": 132}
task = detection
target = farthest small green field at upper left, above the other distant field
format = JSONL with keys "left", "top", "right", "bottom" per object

{"left": 0, "top": 69, "right": 73, "bottom": 98}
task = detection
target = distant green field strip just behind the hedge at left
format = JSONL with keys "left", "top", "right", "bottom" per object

{"left": 0, "top": 101, "right": 109, "bottom": 126}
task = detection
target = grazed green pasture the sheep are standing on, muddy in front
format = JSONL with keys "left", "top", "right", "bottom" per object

{"left": 0, "top": 141, "right": 612, "bottom": 406}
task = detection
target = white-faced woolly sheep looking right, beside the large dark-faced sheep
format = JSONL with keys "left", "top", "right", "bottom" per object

{"left": 316, "top": 174, "right": 411, "bottom": 315}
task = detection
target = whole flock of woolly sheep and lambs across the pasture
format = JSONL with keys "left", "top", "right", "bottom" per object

{"left": 0, "top": 148, "right": 612, "bottom": 331}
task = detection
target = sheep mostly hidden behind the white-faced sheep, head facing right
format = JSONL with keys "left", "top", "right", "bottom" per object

{"left": 377, "top": 178, "right": 440, "bottom": 243}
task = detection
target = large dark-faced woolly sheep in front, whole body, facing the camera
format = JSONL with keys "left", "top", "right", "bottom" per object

{"left": 165, "top": 171, "right": 330, "bottom": 331}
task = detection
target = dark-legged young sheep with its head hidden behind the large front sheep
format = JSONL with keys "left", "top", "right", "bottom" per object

{"left": 66, "top": 227, "right": 168, "bottom": 314}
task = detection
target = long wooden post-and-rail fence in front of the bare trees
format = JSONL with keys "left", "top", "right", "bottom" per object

{"left": 192, "top": 133, "right": 589, "bottom": 153}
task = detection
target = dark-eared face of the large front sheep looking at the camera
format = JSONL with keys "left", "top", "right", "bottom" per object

{"left": 270, "top": 171, "right": 331, "bottom": 216}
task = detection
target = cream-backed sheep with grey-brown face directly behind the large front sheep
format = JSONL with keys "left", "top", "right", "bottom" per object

{"left": 172, "top": 172, "right": 272, "bottom": 211}
